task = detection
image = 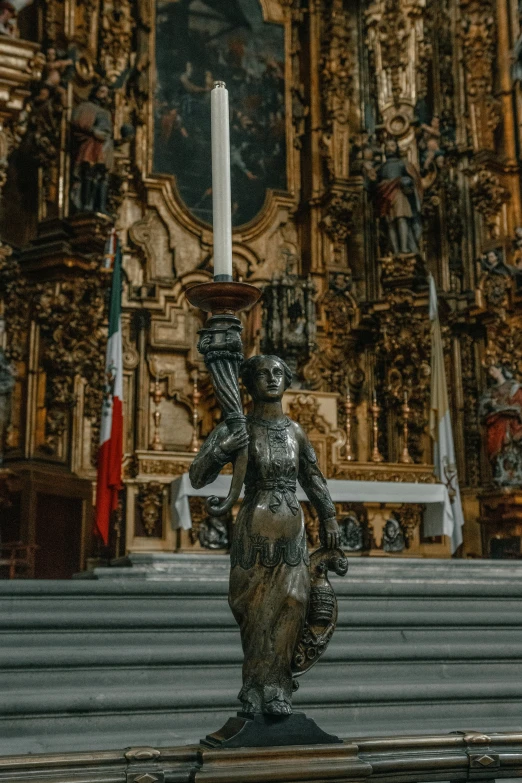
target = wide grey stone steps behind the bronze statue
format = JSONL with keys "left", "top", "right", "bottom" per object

{"left": 0, "top": 555, "right": 522, "bottom": 755}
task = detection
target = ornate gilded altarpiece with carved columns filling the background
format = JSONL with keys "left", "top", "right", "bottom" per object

{"left": 0, "top": 0, "right": 522, "bottom": 568}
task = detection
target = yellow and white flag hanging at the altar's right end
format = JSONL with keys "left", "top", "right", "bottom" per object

{"left": 424, "top": 274, "right": 464, "bottom": 553}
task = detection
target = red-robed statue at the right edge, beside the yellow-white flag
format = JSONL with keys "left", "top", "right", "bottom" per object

{"left": 480, "top": 364, "right": 522, "bottom": 486}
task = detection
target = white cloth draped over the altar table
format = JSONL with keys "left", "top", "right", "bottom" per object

{"left": 170, "top": 473, "right": 453, "bottom": 536}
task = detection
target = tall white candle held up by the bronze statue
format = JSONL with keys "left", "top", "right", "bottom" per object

{"left": 210, "top": 82, "right": 232, "bottom": 280}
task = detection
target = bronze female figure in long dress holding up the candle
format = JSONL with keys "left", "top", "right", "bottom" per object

{"left": 190, "top": 356, "right": 339, "bottom": 715}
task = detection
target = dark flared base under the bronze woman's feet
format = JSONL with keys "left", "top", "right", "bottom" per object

{"left": 201, "top": 712, "right": 342, "bottom": 748}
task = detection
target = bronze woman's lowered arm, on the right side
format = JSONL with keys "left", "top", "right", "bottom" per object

{"left": 295, "top": 424, "right": 339, "bottom": 549}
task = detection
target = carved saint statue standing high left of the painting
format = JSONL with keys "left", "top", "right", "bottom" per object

{"left": 71, "top": 84, "right": 114, "bottom": 213}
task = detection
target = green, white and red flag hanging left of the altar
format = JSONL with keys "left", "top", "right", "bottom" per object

{"left": 96, "top": 232, "right": 123, "bottom": 546}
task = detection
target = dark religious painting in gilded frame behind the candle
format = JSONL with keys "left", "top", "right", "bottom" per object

{"left": 154, "top": 0, "right": 287, "bottom": 226}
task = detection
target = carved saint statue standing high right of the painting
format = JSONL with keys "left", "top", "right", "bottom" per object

{"left": 376, "top": 138, "right": 422, "bottom": 255}
